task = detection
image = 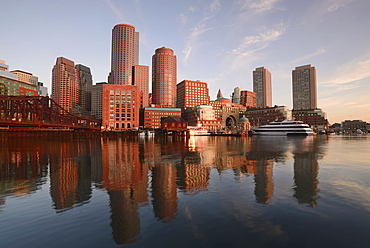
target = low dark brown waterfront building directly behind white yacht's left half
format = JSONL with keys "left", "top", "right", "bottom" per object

{"left": 245, "top": 106, "right": 292, "bottom": 127}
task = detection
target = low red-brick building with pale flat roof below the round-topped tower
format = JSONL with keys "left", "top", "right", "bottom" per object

{"left": 140, "top": 107, "right": 181, "bottom": 129}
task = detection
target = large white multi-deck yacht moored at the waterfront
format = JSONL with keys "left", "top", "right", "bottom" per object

{"left": 252, "top": 120, "right": 314, "bottom": 136}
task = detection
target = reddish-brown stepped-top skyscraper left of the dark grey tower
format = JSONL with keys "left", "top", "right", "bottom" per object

{"left": 51, "top": 57, "right": 79, "bottom": 111}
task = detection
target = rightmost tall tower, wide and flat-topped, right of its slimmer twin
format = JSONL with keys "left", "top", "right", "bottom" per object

{"left": 292, "top": 65, "right": 317, "bottom": 110}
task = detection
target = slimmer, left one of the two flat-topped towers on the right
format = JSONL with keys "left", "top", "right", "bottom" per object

{"left": 253, "top": 67, "right": 272, "bottom": 108}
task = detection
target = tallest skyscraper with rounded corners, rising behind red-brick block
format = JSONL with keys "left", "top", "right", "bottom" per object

{"left": 108, "top": 24, "right": 139, "bottom": 85}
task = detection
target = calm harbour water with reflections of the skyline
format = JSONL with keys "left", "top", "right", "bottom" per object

{"left": 0, "top": 135, "right": 370, "bottom": 248}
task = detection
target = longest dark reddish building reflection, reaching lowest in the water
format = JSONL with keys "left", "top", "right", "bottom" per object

{"left": 102, "top": 138, "right": 148, "bottom": 244}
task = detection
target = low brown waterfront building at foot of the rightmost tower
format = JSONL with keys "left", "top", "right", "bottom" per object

{"left": 292, "top": 108, "right": 329, "bottom": 131}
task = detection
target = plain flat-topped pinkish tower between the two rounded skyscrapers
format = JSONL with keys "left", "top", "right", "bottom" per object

{"left": 132, "top": 65, "right": 149, "bottom": 107}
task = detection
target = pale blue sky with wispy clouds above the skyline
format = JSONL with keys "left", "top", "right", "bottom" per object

{"left": 0, "top": 0, "right": 370, "bottom": 123}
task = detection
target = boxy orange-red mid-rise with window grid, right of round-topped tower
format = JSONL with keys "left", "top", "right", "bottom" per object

{"left": 176, "top": 80, "right": 210, "bottom": 108}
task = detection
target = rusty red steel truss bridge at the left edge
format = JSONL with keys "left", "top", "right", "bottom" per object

{"left": 0, "top": 96, "right": 100, "bottom": 131}
